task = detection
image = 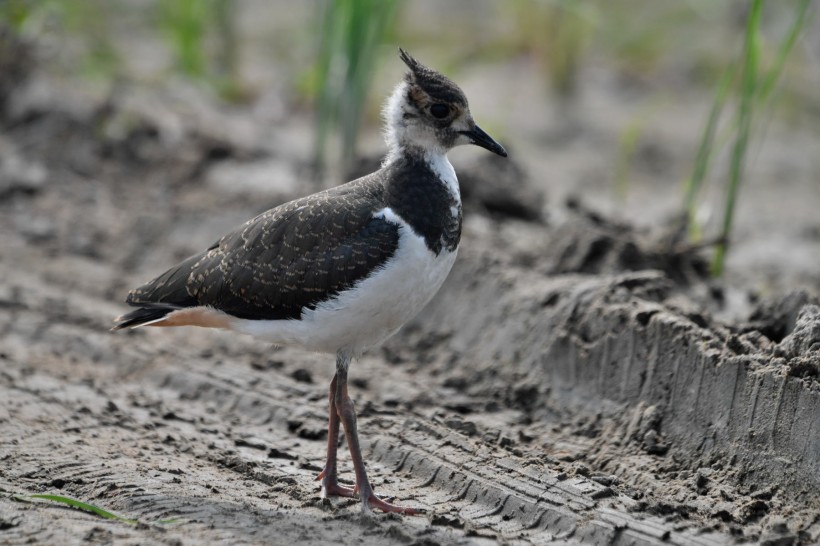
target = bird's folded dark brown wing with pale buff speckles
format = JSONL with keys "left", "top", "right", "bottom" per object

{"left": 127, "top": 176, "right": 399, "bottom": 320}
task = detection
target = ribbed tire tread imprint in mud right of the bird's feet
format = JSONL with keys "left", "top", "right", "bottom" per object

{"left": 371, "top": 418, "right": 723, "bottom": 544}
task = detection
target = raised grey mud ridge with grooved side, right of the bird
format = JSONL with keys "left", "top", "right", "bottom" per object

{"left": 391, "top": 243, "right": 820, "bottom": 533}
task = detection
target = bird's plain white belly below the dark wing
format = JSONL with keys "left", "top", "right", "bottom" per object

{"left": 233, "top": 209, "right": 457, "bottom": 355}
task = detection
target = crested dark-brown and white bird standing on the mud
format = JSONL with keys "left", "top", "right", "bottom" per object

{"left": 112, "top": 48, "right": 507, "bottom": 515}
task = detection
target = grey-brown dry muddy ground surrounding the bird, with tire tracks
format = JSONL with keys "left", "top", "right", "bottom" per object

{"left": 0, "top": 69, "right": 820, "bottom": 544}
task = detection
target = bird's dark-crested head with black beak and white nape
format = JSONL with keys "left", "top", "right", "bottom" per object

{"left": 384, "top": 49, "right": 507, "bottom": 157}
